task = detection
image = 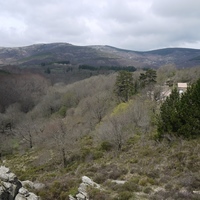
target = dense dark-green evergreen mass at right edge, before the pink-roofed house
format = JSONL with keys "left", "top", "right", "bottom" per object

{"left": 158, "top": 79, "right": 200, "bottom": 138}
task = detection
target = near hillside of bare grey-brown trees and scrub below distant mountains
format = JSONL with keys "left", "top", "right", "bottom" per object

{"left": 0, "top": 65, "right": 200, "bottom": 200}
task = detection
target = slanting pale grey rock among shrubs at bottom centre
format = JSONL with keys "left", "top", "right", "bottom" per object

{"left": 69, "top": 176, "right": 100, "bottom": 200}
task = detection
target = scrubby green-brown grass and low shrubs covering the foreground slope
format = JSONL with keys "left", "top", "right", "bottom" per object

{"left": 2, "top": 133, "right": 200, "bottom": 200}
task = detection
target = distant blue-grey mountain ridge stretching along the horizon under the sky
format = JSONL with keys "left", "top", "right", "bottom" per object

{"left": 0, "top": 43, "right": 200, "bottom": 68}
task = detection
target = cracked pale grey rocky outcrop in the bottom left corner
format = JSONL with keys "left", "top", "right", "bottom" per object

{"left": 0, "top": 166, "right": 40, "bottom": 200}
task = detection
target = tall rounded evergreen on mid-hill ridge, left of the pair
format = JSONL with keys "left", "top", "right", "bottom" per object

{"left": 114, "top": 71, "right": 134, "bottom": 102}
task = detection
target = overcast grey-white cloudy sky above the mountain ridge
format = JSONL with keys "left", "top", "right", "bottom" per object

{"left": 0, "top": 0, "right": 200, "bottom": 51}
